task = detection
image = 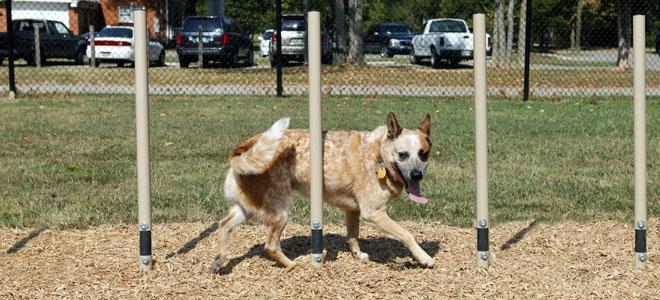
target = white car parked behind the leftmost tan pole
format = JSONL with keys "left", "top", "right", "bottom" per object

{"left": 87, "top": 26, "right": 165, "bottom": 67}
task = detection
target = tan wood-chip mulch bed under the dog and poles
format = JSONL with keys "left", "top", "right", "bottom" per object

{"left": 0, "top": 218, "right": 660, "bottom": 299}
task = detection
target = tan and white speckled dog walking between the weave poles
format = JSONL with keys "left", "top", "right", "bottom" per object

{"left": 211, "top": 112, "right": 435, "bottom": 273}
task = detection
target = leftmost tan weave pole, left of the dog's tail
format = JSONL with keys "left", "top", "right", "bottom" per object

{"left": 133, "top": 9, "right": 153, "bottom": 271}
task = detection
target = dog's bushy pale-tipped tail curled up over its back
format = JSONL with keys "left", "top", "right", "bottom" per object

{"left": 229, "top": 118, "right": 290, "bottom": 175}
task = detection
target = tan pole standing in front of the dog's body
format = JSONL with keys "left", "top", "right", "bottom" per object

{"left": 307, "top": 11, "right": 323, "bottom": 266}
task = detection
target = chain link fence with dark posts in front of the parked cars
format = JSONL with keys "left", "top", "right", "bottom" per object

{"left": 0, "top": 0, "right": 660, "bottom": 99}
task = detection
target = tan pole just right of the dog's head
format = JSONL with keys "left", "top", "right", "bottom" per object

{"left": 473, "top": 14, "right": 489, "bottom": 268}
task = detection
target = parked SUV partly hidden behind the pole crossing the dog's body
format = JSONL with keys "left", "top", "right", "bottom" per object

{"left": 270, "top": 14, "right": 332, "bottom": 67}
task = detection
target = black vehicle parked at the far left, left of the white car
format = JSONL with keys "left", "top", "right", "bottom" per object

{"left": 0, "top": 19, "right": 87, "bottom": 66}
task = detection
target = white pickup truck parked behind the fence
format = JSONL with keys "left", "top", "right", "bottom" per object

{"left": 410, "top": 19, "right": 492, "bottom": 68}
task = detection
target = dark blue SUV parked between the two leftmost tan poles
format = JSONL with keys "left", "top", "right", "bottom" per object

{"left": 176, "top": 16, "right": 254, "bottom": 68}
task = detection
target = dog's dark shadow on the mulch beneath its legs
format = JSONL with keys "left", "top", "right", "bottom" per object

{"left": 218, "top": 234, "right": 440, "bottom": 275}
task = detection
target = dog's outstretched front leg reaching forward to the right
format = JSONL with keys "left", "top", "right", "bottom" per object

{"left": 362, "top": 210, "right": 435, "bottom": 267}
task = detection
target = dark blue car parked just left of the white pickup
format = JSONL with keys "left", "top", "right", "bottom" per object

{"left": 364, "top": 23, "right": 413, "bottom": 58}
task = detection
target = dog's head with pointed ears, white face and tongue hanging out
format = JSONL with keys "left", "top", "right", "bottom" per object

{"left": 381, "top": 112, "right": 431, "bottom": 204}
